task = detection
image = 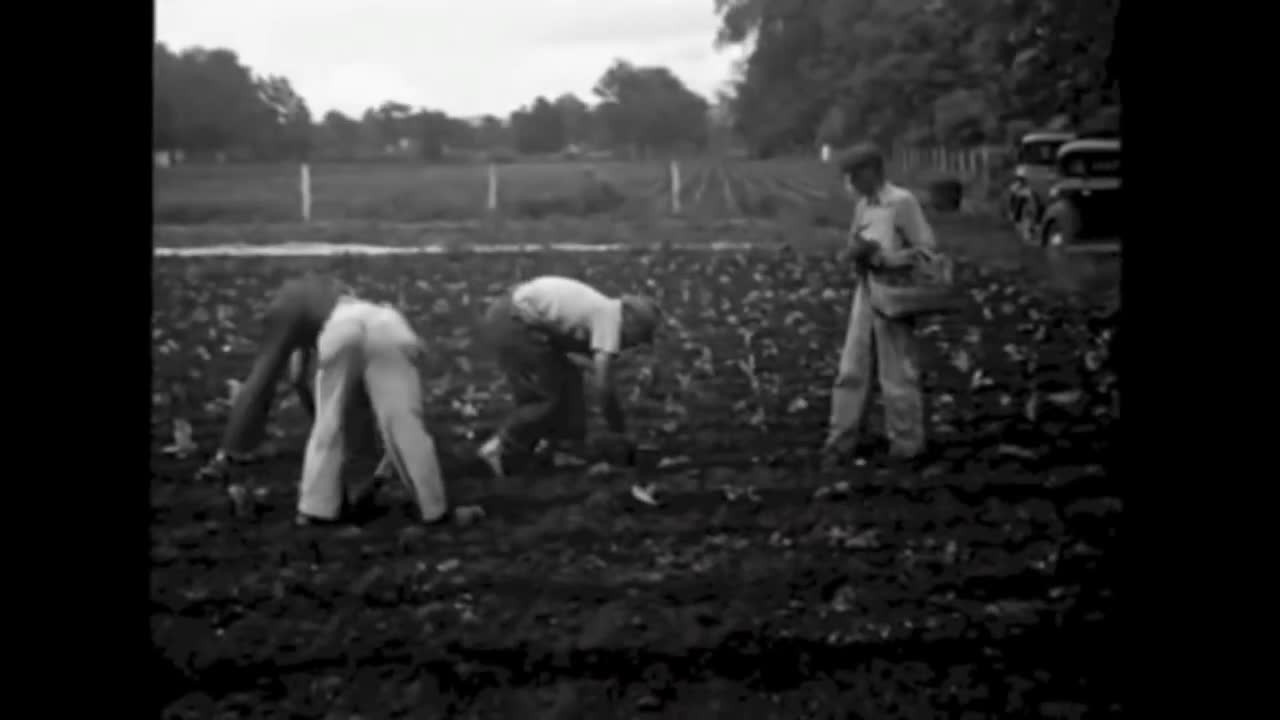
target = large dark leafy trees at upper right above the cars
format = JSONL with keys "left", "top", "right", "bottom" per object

{"left": 716, "top": 0, "right": 1120, "bottom": 155}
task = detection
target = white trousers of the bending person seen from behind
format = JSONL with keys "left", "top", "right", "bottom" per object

{"left": 298, "top": 300, "right": 448, "bottom": 521}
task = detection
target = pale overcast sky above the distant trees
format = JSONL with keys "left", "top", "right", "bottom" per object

{"left": 156, "top": 0, "right": 739, "bottom": 118}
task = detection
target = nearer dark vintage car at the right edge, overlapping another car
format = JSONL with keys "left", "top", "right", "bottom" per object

{"left": 1036, "top": 138, "right": 1123, "bottom": 250}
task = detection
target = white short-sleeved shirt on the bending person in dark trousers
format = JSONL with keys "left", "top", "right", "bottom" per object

{"left": 511, "top": 275, "right": 622, "bottom": 354}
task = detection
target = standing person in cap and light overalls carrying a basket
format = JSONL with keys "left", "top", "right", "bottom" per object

{"left": 824, "top": 145, "right": 936, "bottom": 462}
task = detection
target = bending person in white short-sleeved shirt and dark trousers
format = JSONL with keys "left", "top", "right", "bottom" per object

{"left": 479, "top": 275, "right": 662, "bottom": 477}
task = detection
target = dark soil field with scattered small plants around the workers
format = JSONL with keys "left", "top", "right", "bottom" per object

{"left": 151, "top": 243, "right": 1121, "bottom": 719}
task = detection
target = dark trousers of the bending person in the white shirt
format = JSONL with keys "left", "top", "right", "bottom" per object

{"left": 485, "top": 296, "right": 586, "bottom": 456}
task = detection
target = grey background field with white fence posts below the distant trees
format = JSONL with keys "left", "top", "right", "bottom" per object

{"left": 154, "top": 158, "right": 957, "bottom": 225}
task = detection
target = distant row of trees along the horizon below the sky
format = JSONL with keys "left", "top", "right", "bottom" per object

{"left": 152, "top": 44, "right": 723, "bottom": 161}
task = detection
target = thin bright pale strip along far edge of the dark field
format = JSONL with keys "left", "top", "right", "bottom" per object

{"left": 154, "top": 242, "right": 754, "bottom": 258}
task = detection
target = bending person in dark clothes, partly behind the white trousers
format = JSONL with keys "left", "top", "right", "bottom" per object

{"left": 200, "top": 274, "right": 390, "bottom": 479}
